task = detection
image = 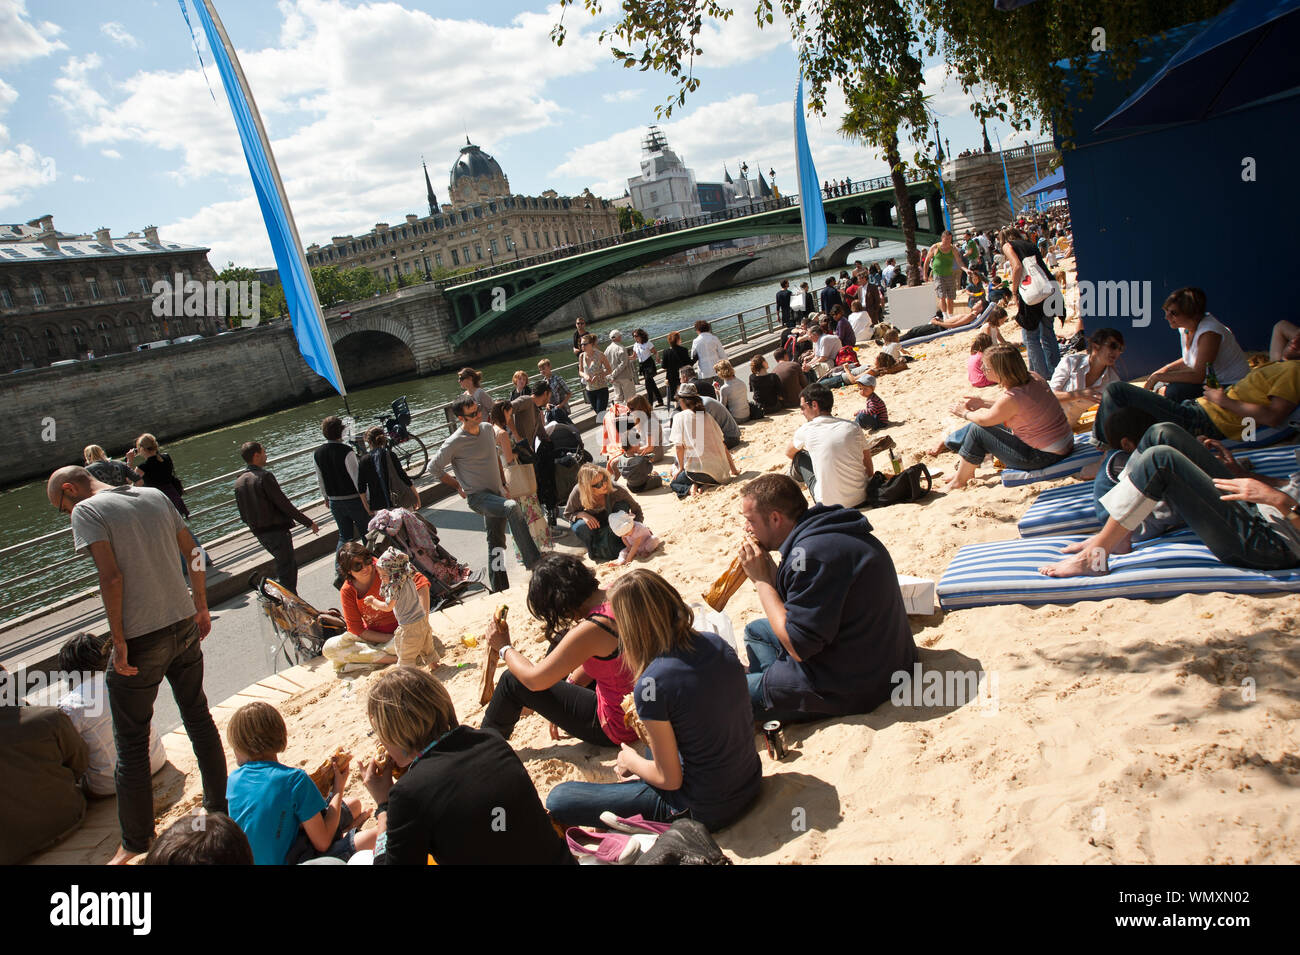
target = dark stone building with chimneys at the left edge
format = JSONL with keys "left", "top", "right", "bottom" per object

{"left": 0, "top": 216, "right": 225, "bottom": 373}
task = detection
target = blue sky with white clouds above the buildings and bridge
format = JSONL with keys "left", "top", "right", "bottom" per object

{"left": 0, "top": 0, "right": 1040, "bottom": 270}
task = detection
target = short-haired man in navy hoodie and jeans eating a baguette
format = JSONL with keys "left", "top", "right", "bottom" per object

{"left": 740, "top": 474, "right": 917, "bottom": 722}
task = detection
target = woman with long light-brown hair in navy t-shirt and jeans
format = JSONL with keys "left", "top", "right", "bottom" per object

{"left": 546, "top": 569, "right": 763, "bottom": 829}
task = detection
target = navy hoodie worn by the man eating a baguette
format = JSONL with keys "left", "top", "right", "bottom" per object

{"left": 763, "top": 504, "right": 917, "bottom": 716}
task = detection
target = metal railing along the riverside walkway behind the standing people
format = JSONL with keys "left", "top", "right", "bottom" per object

{"left": 0, "top": 298, "right": 779, "bottom": 620}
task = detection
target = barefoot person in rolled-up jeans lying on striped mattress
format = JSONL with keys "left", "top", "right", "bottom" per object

{"left": 1039, "top": 422, "right": 1300, "bottom": 577}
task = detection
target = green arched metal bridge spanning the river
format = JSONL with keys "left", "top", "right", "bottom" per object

{"left": 438, "top": 178, "right": 943, "bottom": 347}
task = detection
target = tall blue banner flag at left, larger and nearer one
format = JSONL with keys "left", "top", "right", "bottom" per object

{"left": 194, "top": 0, "right": 347, "bottom": 396}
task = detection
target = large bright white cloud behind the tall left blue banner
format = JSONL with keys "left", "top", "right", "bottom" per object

{"left": 55, "top": 0, "right": 623, "bottom": 264}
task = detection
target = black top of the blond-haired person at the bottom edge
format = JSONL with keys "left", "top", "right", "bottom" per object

{"left": 374, "top": 726, "right": 573, "bottom": 865}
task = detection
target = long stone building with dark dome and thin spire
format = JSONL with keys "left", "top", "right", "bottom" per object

{"left": 307, "top": 138, "right": 619, "bottom": 281}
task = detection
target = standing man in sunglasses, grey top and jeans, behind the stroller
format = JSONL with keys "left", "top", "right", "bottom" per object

{"left": 433, "top": 395, "right": 542, "bottom": 592}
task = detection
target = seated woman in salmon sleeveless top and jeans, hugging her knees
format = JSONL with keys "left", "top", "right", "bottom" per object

{"left": 933, "top": 344, "right": 1074, "bottom": 490}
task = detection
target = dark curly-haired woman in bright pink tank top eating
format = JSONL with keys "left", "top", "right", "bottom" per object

{"left": 482, "top": 554, "right": 637, "bottom": 746}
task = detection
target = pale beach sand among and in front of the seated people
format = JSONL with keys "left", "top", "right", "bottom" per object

{"left": 160, "top": 263, "right": 1300, "bottom": 864}
